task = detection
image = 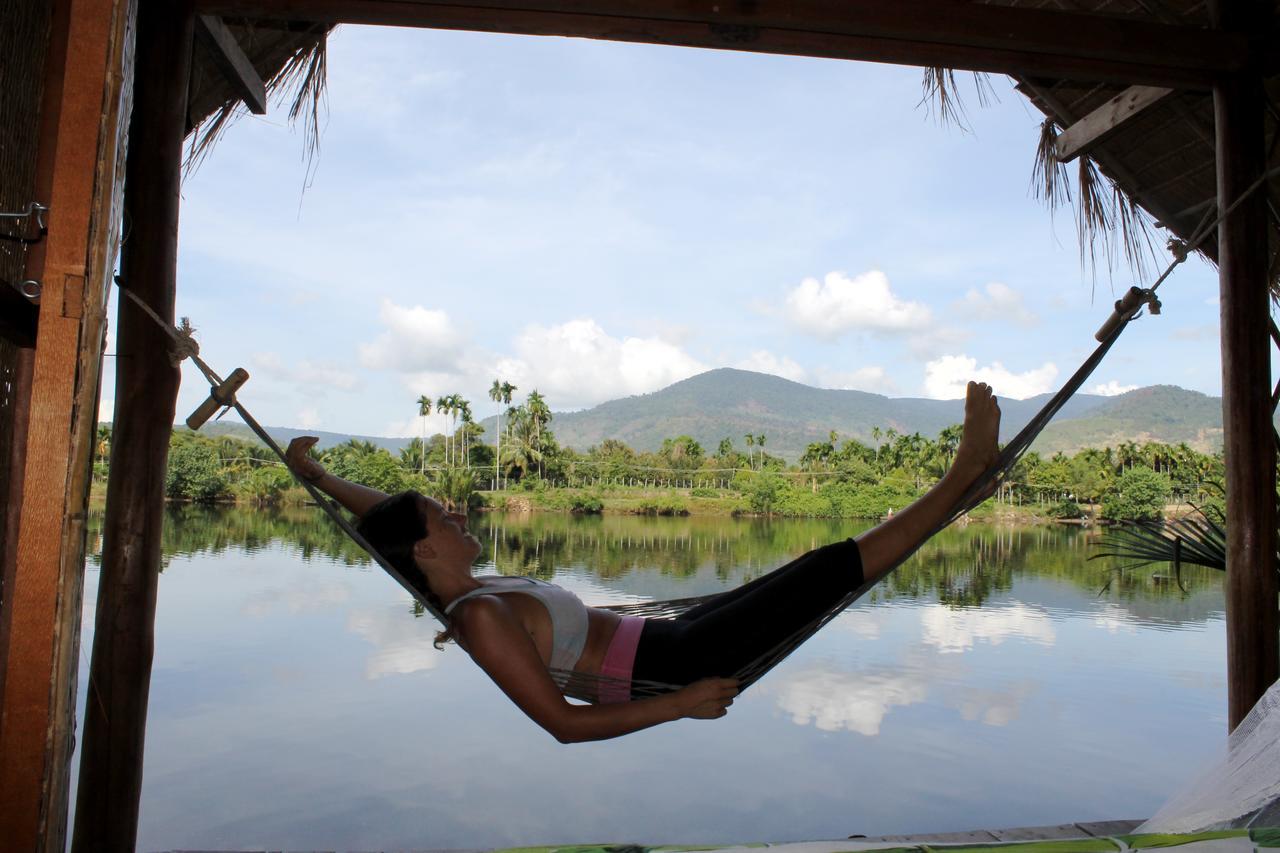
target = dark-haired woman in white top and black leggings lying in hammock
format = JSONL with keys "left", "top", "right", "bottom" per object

{"left": 287, "top": 382, "right": 1000, "bottom": 743}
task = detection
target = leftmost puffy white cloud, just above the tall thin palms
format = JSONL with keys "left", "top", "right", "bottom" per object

{"left": 360, "top": 298, "right": 463, "bottom": 373}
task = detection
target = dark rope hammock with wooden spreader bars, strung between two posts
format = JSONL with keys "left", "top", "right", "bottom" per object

{"left": 107, "top": 173, "right": 1270, "bottom": 702}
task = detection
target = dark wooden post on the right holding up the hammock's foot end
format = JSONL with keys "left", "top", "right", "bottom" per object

{"left": 1213, "top": 0, "right": 1280, "bottom": 729}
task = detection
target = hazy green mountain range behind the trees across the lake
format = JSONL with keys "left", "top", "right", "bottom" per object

{"left": 185, "top": 368, "right": 1222, "bottom": 461}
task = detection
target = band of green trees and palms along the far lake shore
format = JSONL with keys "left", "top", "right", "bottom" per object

{"left": 95, "top": 379, "right": 1222, "bottom": 520}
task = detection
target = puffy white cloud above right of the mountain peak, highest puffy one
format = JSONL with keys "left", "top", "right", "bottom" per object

{"left": 785, "top": 270, "right": 933, "bottom": 338}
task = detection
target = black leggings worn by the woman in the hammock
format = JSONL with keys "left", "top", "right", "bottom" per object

{"left": 631, "top": 539, "right": 863, "bottom": 684}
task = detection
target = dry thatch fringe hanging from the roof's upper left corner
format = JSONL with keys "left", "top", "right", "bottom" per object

{"left": 183, "top": 27, "right": 332, "bottom": 178}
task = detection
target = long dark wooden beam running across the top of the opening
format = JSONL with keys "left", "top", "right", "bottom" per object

{"left": 197, "top": 0, "right": 1249, "bottom": 90}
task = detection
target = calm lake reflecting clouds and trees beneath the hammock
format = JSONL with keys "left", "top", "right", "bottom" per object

{"left": 70, "top": 507, "right": 1226, "bottom": 850}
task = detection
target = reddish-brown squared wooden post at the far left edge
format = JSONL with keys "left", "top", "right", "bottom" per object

{"left": 0, "top": 0, "right": 133, "bottom": 853}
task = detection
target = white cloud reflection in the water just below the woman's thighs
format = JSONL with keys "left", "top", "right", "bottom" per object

{"left": 774, "top": 667, "right": 929, "bottom": 736}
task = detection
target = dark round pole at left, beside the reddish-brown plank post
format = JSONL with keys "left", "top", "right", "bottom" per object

{"left": 72, "top": 0, "right": 195, "bottom": 853}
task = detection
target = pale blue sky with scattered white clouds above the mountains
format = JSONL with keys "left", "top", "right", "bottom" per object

{"left": 102, "top": 27, "right": 1221, "bottom": 435}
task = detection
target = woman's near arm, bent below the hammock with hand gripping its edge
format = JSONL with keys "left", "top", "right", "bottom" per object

{"left": 453, "top": 596, "right": 737, "bottom": 743}
